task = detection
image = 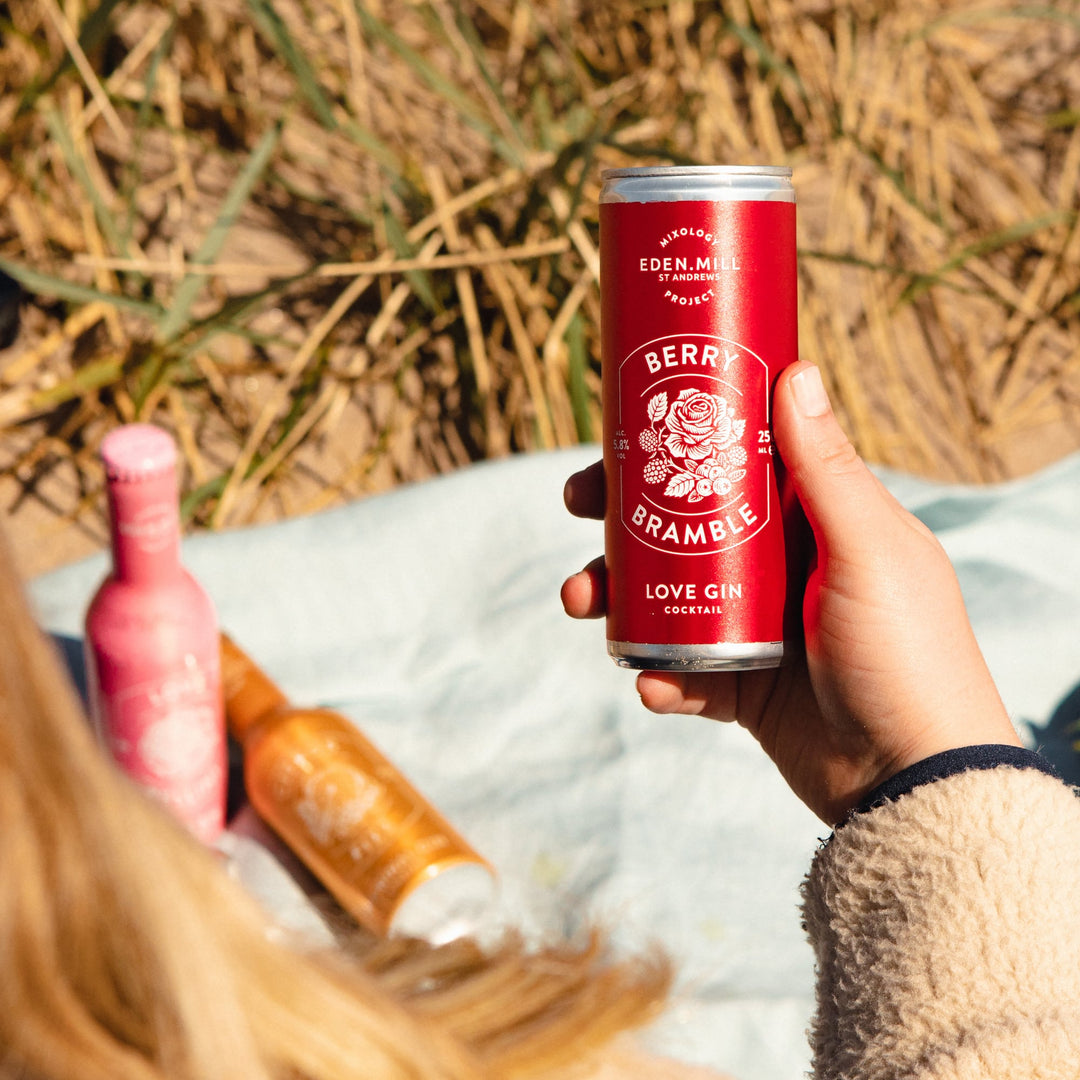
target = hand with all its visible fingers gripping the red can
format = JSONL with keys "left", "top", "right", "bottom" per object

{"left": 562, "top": 363, "right": 1020, "bottom": 825}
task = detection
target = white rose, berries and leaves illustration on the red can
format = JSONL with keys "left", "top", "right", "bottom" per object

{"left": 638, "top": 389, "right": 747, "bottom": 502}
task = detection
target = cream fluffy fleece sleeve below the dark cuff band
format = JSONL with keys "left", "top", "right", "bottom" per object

{"left": 802, "top": 766, "right": 1080, "bottom": 1080}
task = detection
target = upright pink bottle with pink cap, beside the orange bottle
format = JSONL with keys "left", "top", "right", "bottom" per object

{"left": 86, "top": 423, "right": 228, "bottom": 843}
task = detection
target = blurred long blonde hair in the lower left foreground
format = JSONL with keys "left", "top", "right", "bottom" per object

{"left": 0, "top": 527, "right": 670, "bottom": 1080}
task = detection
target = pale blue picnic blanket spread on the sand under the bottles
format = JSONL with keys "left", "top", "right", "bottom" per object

{"left": 32, "top": 447, "right": 1080, "bottom": 1080}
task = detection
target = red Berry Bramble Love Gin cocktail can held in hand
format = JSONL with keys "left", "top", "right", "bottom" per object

{"left": 599, "top": 166, "right": 805, "bottom": 671}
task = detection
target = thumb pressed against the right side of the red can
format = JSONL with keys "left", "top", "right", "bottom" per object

{"left": 772, "top": 361, "right": 901, "bottom": 555}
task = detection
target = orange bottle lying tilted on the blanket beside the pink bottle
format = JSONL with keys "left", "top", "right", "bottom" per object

{"left": 221, "top": 635, "right": 495, "bottom": 942}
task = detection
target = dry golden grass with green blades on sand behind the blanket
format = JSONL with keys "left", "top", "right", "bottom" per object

{"left": 0, "top": 0, "right": 1080, "bottom": 552}
